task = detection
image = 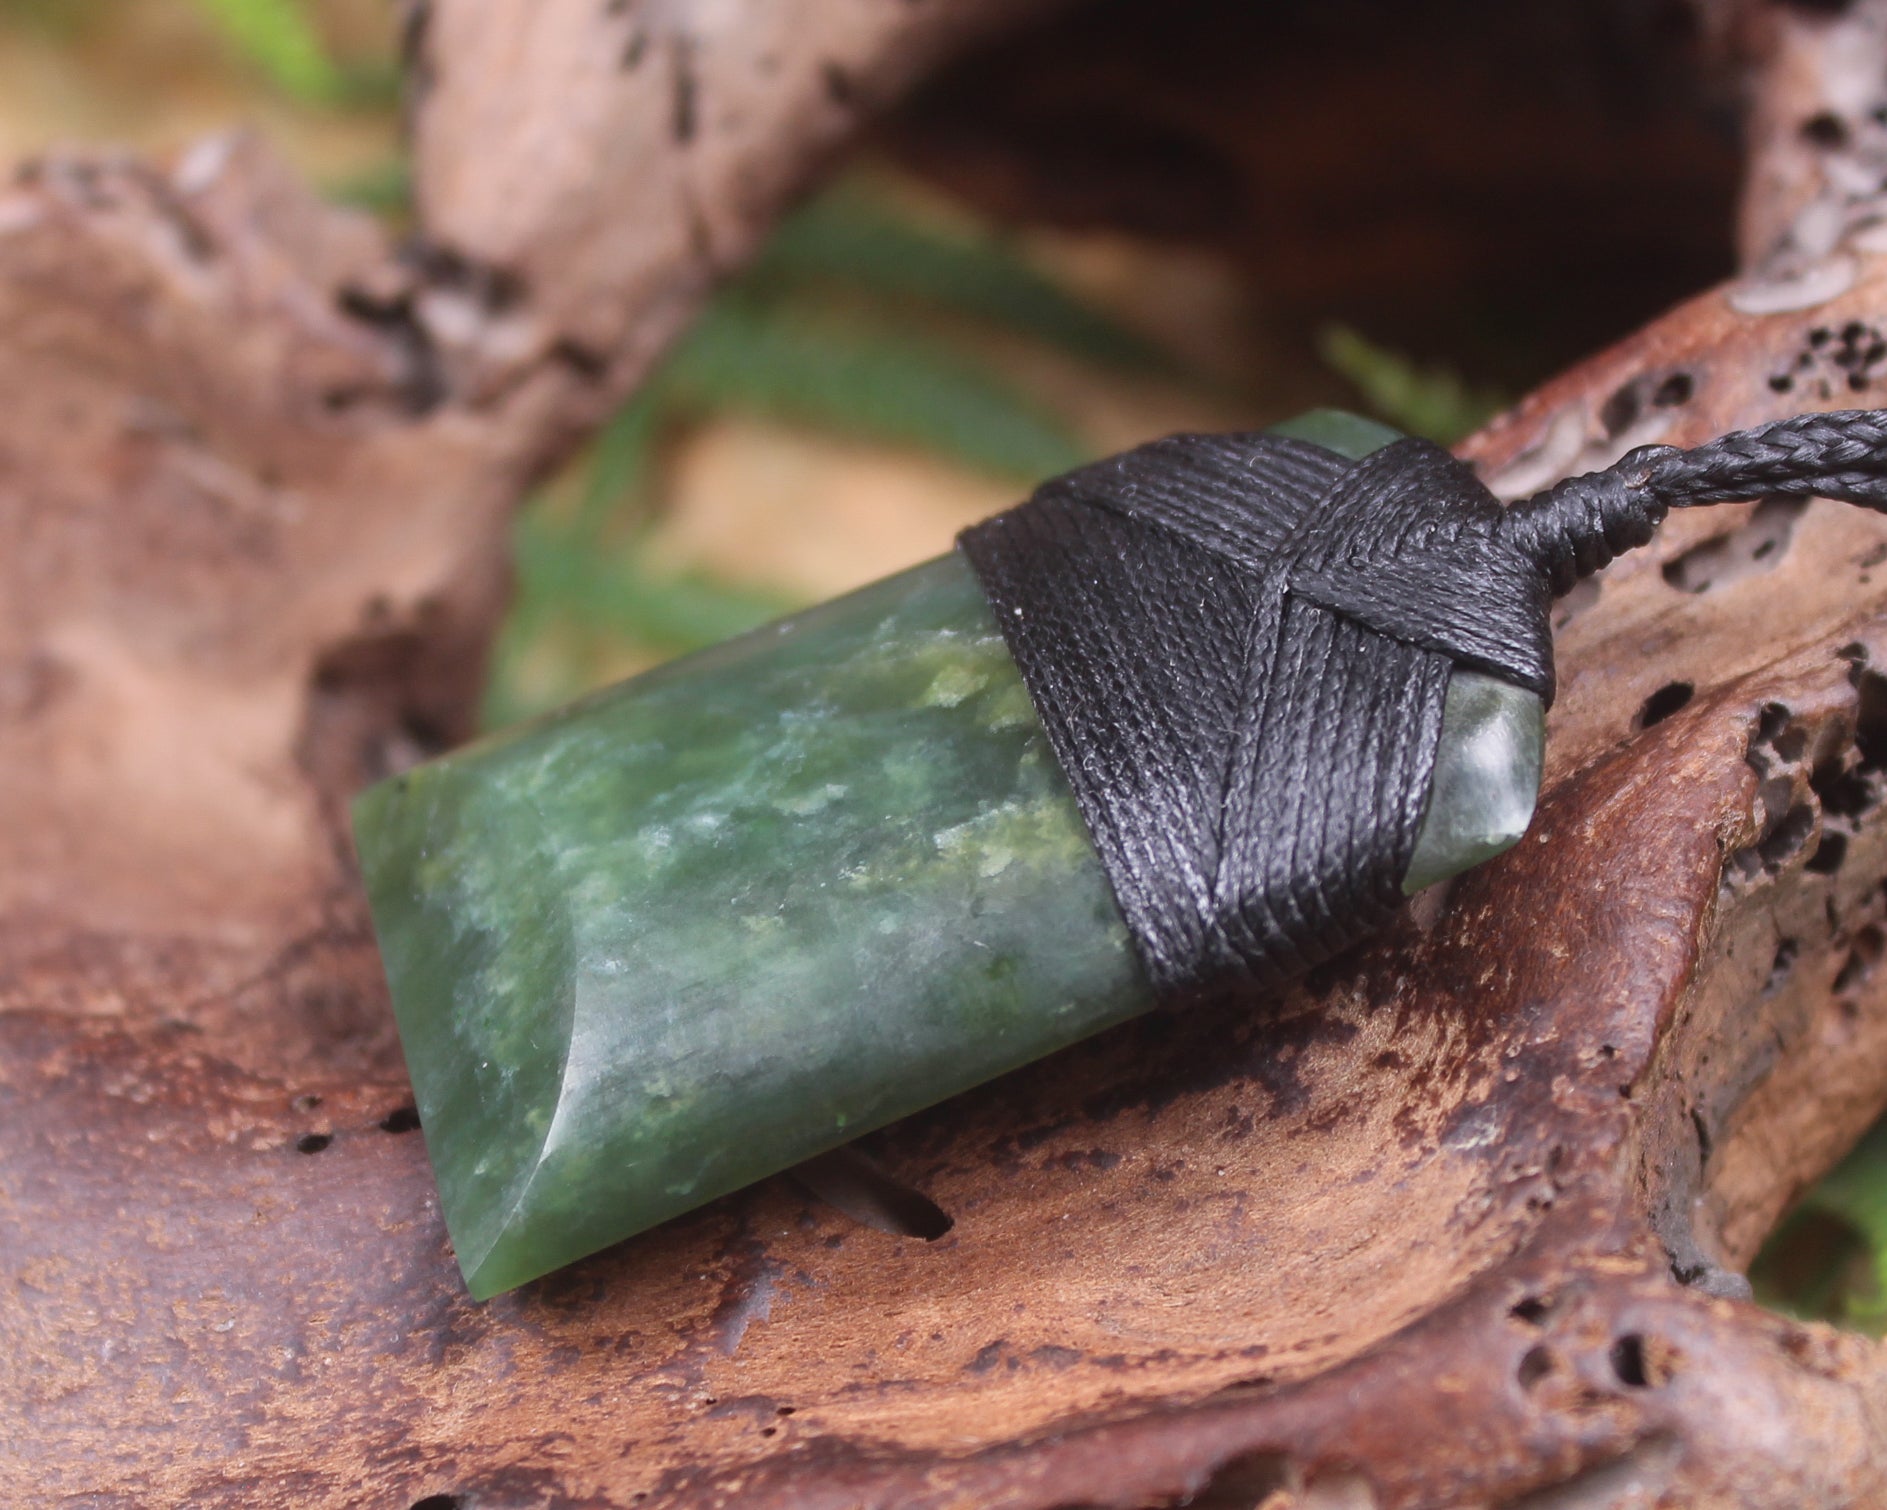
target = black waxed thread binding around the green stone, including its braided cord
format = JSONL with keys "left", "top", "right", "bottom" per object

{"left": 959, "top": 411, "right": 1887, "bottom": 1004}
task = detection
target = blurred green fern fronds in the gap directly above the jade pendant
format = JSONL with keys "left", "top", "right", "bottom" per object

{"left": 485, "top": 181, "right": 1170, "bottom": 725}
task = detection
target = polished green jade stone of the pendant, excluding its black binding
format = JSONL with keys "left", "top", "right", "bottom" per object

{"left": 355, "top": 415, "right": 1538, "bottom": 1299}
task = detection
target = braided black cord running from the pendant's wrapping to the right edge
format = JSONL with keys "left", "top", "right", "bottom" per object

{"left": 1500, "top": 410, "right": 1887, "bottom": 595}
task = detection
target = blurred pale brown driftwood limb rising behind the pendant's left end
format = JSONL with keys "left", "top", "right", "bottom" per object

{"left": 0, "top": 0, "right": 1047, "bottom": 1072}
